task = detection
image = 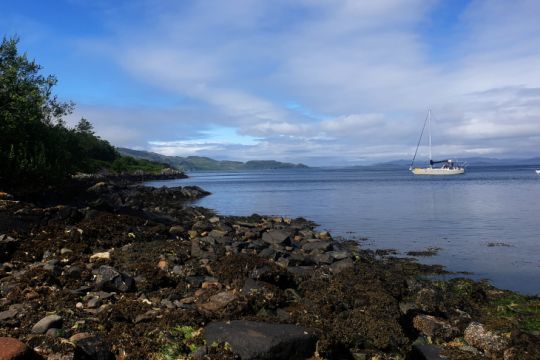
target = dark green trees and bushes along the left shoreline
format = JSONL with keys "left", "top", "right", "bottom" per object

{"left": 0, "top": 37, "right": 168, "bottom": 186}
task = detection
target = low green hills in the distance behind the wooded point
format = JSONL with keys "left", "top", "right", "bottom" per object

{"left": 117, "top": 148, "right": 307, "bottom": 171}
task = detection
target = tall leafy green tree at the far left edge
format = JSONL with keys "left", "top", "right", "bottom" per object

{"left": 0, "top": 37, "right": 78, "bottom": 186}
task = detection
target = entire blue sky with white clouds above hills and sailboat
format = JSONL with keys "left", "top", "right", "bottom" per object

{"left": 0, "top": 0, "right": 540, "bottom": 166}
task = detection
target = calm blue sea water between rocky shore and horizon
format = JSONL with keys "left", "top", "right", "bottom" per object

{"left": 149, "top": 167, "right": 540, "bottom": 294}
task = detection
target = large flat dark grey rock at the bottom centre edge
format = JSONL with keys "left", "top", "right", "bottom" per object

{"left": 204, "top": 320, "right": 317, "bottom": 360}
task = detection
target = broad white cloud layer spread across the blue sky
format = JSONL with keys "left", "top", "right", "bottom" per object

{"left": 61, "top": 0, "right": 540, "bottom": 163}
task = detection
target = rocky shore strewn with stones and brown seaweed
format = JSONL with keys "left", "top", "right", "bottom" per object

{"left": 0, "top": 178, "right": 540, "bottom": 360}
